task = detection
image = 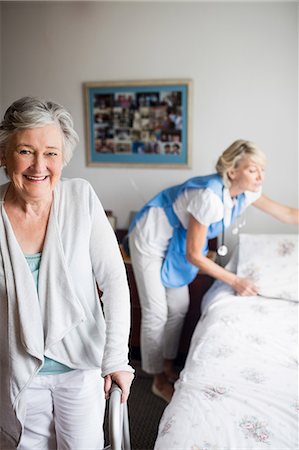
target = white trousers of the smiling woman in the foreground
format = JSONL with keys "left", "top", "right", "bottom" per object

{"left": 18, "top": 370, "right": 105, "bottom": 450}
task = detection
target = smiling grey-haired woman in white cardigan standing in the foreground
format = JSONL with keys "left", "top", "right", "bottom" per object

{"left": 0, "top": 97, "right": 133, "bottom": 450}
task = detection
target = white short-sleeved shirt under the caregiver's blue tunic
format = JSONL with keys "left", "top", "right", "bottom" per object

{"left": 133, "top": 188, "right": 261, "bottom": 257}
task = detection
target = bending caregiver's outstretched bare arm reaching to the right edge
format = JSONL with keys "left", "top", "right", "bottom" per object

{"left": 253, "top": 195, "right": 299, "bottom": 225}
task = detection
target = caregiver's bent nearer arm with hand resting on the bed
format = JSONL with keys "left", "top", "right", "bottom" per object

{"left": 186, "top": 214, "right": 257, "bottom": 295}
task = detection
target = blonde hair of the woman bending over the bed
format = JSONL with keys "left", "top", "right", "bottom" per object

{"left": 216, "top": 139, "right": 266, "bottom": 188}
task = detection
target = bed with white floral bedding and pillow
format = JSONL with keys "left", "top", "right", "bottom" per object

{"left": 155, "top": 234, "right": 298, "bottom": 450}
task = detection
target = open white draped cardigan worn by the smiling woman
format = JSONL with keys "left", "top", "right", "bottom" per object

{"left": 0, "top": 179, "right": 133, "bottom": 449}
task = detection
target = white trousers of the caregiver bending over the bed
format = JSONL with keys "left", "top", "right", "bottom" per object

{"left": 129, "top": 233, "right": 189, "bottom": 374}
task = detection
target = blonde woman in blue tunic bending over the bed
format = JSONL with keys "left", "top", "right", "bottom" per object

{"left": 129, "top": 140, "right": 298, "bottom": 401}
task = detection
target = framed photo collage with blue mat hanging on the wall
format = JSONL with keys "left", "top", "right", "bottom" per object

{"left": 83, "top": 80, "right": 191, "bottom": 168}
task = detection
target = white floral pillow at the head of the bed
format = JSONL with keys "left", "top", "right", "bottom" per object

{"left": 237, "top": 234, "right": 299, "bottom": 302}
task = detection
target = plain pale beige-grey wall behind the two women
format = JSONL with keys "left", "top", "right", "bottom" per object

{"left": 0, "top": 1, "right": 298, "bottom": 236}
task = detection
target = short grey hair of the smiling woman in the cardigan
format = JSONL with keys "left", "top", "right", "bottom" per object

{"left": 0, "top": 97, "right": 79, "bottom": 165}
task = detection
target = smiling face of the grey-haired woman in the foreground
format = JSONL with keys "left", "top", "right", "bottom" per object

{"left": 5, "top": 124, "right": 63, "bottom": 199}
